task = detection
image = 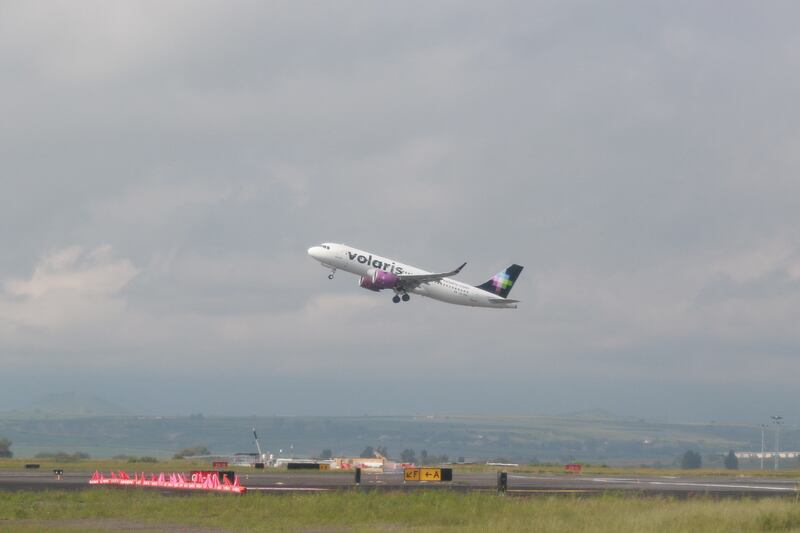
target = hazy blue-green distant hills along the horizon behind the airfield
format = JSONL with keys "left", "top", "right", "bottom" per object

{"left": 0, "top": 412, "right": 776, "bottom": 462}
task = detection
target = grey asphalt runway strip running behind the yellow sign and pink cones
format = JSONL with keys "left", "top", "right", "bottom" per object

{"left": 0, "top": 469, "right": 798, "bottom": 497}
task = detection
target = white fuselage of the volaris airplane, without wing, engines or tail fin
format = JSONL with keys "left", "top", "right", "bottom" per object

{"left": 308, "top": 243, "right": 517, "bottom": 309}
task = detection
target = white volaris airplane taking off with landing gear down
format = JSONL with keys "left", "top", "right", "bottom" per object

{"left": 308, "top": 242, "right": 522, "bottom": 309}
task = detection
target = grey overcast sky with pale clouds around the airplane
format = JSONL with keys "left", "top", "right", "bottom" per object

{"left": 0, "top": 0, "right": 800, "bottom": 423}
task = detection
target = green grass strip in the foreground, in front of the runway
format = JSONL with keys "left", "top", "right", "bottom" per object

{"left": 0, "top": 489, "right": 800, "bottom": 533}
